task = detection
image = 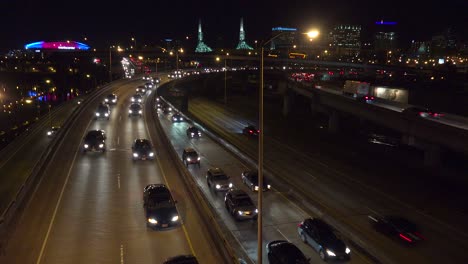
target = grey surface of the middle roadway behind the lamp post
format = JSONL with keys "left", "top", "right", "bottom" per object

{"left": 159, "top": 100, "right": 372, "bottom": 263}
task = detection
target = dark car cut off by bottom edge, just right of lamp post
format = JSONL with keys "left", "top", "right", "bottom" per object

{"left": 266, "top": 240, "right": 309, "bottom": 264}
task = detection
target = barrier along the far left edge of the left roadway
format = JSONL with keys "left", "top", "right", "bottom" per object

{"left": 0, "top": 80, "right": 127, "bottom": 254}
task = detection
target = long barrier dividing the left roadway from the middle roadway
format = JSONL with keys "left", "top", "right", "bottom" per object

{"left": 152, "top": 89, "right": 253, "bottom": 264}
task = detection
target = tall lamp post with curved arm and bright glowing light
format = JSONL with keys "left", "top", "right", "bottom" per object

{"left": 257, "top": 30, "right": 319, "bottom": 264}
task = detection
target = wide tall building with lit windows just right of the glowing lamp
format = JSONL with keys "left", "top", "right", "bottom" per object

{"left": 329, "top": 25, "right": 361, "bottom": 57}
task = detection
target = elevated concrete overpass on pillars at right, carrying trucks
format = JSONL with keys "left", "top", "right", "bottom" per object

{"left": 283, "top": 82, "right": 468, "bottom": 166}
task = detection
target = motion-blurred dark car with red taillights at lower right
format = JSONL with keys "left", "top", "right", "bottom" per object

{"left": 369, "top": 215, "right": 425, "bottom": 244}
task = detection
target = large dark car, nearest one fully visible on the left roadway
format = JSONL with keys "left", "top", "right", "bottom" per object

{"left": 143, "top": 184, "right": 180, "bottom": 229}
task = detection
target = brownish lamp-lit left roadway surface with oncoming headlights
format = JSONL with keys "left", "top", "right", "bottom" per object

{"left": 0, "top": 78, "right": 227, "bottom": 264}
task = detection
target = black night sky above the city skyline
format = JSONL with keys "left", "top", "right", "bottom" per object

{"left": 0, "top": 0, "right": 468, "bottom": 51}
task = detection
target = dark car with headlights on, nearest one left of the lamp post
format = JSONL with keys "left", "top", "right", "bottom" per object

{"left": 224, "top": 189, "right": 258, "bottom": 220}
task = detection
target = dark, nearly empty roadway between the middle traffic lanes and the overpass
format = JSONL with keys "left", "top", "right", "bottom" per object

{"left": 177, "top": 89, "right": 468, "bottom": 263}
